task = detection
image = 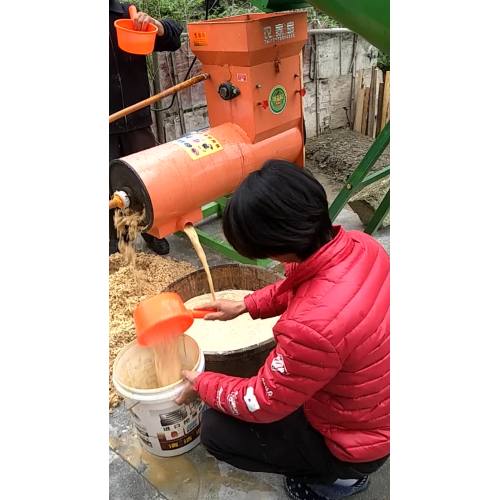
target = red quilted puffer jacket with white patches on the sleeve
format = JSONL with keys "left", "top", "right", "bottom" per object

{"left": 195, "top": 226, "right": 389, "bottom": 462}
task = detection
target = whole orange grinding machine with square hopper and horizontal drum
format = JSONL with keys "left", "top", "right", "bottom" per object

{"left": 110, "top": 12, "right": 307, "bottom": 238}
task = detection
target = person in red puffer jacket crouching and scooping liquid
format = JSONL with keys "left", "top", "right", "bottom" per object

{"left": 178, "top": 160, "right": 389, "bottom": 500}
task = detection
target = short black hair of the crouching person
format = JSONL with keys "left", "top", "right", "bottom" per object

{"left": 223, "top": 160, "right": 334, "bottom": 260}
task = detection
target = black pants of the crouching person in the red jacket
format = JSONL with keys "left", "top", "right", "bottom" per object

{"left": 201, "top": 408, "right": 388, "bottom": 483}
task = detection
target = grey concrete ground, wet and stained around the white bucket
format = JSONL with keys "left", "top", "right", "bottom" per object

{"left": 109, "top": 176, "right": 390, "bottom": 500}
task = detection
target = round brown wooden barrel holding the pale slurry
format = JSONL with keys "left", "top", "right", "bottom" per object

{"left": 165, "top": 264, "right": 282, "bottom": 377}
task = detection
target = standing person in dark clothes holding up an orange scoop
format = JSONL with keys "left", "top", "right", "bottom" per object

{"left": 109, "top": 0, "right": 182, "bottom": 255}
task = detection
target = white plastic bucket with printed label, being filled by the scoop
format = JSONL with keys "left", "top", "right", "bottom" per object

{"left": 113, "top": 335, "right": 205, "bottom": 457}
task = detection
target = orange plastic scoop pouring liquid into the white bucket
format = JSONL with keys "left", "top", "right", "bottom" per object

{"left": 134, "top": 292, "right": 214, "bottom": 346}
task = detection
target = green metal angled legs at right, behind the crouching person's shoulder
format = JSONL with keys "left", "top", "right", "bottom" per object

{"left": 328, "top": 123, "right": 390, "bottom": 234}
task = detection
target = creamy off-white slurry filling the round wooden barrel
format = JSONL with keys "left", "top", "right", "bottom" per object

{"left": 186, "top": 290, "right": 278, "bottom": 352}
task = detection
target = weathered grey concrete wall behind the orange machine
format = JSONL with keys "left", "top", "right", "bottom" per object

{"left": 153, "top": 33, "right": 376, "bottom": 142}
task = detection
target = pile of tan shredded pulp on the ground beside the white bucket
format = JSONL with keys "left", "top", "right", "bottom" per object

{"left": 109, "top": 251, "right": 195, "bottom": 408}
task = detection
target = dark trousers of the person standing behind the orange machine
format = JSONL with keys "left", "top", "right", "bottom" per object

{"left": 109, "top": 127, "right": 158, "bottom": 246}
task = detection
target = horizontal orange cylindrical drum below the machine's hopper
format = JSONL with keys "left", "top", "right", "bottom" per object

{"left": 110, "top": 123, "right": 303, "bottom": 238}
